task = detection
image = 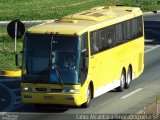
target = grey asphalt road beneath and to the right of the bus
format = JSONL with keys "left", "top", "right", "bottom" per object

{"left": 0, "top": 14, "right": 160, "bottom": 120}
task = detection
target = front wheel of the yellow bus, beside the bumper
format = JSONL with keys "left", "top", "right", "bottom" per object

{"left": 82, "top": 85, "right": 92, "bottom": 108}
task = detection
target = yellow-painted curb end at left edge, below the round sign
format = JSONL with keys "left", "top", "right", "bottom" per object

{"left": 0, "top": 70, "right": 21, "bottom": 77}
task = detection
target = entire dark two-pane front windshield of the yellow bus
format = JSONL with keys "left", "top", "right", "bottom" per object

{"left": 23, "top": 34, "right": 79, "bottom": 84}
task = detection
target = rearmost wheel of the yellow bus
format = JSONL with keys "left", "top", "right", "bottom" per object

{"left": 125, "top": 67, "right": 132, "bottom": 89}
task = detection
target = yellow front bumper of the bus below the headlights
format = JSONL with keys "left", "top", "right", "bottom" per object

{"left": 21, "top": 92, "right": 85, "bottom": 106}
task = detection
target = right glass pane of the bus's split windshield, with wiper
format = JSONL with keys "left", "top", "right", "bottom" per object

{"left": 50, "top": 35, "right": 80, "bottom": 84}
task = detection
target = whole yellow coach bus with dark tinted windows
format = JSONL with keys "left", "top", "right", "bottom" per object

{"left": 21, "top": 6, "right": 144, "bottom": 107}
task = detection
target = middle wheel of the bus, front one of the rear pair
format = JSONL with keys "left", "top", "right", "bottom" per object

{"left": 116, "top": 70, "right": 126, "bottom": 92}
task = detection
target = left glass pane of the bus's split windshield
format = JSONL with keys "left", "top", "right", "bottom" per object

{"left": 23, "top": 34, "right": 51, "bottom": 83}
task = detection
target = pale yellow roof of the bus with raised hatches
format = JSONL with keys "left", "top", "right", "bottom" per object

{"left": 28, "top": 6, "right": 142, "bottom": 35}
